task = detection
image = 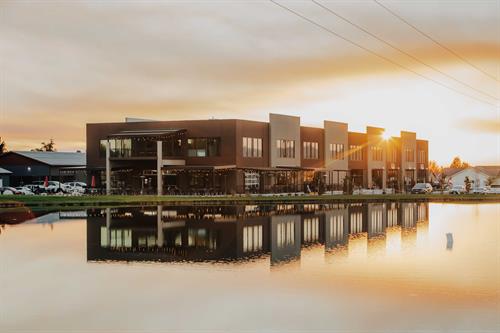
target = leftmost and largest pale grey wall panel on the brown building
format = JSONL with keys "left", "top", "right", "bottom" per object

{"left": 269, "top": 113, "right": 301, "bottom": 167}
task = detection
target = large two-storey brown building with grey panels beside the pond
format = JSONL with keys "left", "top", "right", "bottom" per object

{"left": 87, "top": 114, "right": 428, "bottom": 194}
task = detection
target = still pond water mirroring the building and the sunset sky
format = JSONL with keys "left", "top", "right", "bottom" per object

{"left": 0, "top": 203, "right": 500, "bottom": 332}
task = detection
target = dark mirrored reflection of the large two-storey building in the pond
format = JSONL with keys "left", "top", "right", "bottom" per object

{"left": 87, "top": 203, "right": 428, "bottom": 264}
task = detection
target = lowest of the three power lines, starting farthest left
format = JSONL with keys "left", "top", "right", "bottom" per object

{"left": 269, "top": 0, "right": 498, "bottom": 108}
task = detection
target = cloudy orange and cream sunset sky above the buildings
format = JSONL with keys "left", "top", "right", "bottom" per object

{"left": 0, "top": 0, "right": 500, "bottom": 165}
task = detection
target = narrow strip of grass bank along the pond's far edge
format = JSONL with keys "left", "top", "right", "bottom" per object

{"left": 0, "top": 194, "right": 500, "bottom": 208}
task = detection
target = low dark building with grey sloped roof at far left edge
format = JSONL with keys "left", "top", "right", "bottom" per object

{"left": 0, "top": 151, "right": 86, "bottom": 186}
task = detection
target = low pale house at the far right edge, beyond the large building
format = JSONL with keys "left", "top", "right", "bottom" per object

{"left": 444, "top": 166, "right": 500, "bottom": 188}
